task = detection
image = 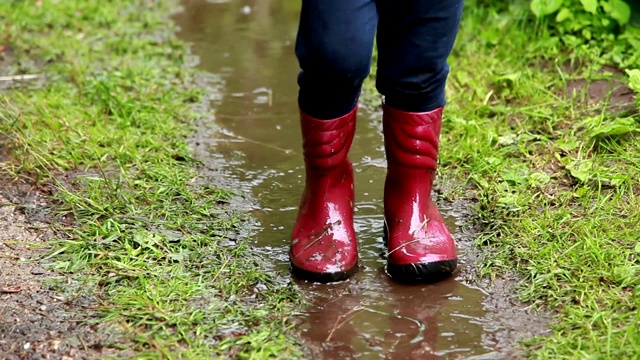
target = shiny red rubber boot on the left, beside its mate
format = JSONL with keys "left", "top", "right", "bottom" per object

{"left": 289, "top": 109, "right": 358, "bottom": 282}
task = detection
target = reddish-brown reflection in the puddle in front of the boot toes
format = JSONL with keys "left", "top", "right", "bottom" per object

{"left": 302, "top": 276, "right": 489, "bottom": 359}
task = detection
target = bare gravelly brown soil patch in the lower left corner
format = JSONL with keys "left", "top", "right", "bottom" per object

{"left": 0, "top": 186, "right": 128, "bottom": 359}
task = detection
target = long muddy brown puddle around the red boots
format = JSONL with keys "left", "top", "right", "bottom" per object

{"left": 174, "top": 0, "right": 547, "bottom": 359}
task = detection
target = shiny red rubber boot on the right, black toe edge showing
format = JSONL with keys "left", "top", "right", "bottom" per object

{"left": 383, "top": 105, "right": 457, "bottom": 282}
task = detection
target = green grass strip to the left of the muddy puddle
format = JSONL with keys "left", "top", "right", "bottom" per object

{"left": 0, "top": 0, "right": 299, "bottom": 358}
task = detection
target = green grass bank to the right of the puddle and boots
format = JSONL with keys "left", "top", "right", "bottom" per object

{"left": 439, "top": 4, "right": 640, "bottom": 359}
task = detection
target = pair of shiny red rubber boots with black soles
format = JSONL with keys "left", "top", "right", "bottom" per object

{"left": 290, "top": 105, "right": 457, "bottom": 282}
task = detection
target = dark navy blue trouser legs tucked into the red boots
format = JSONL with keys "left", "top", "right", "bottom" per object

{"left": 296, "top": 0, "right": 463, "bottom": 119}
